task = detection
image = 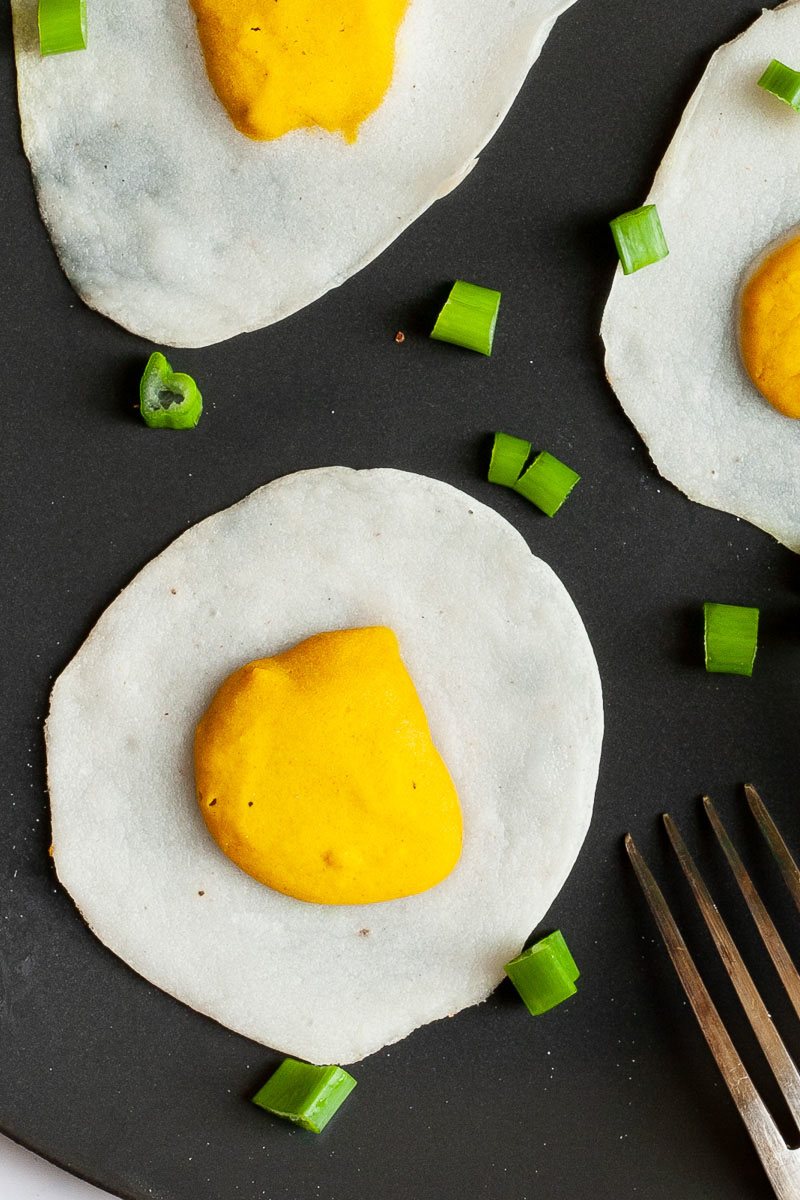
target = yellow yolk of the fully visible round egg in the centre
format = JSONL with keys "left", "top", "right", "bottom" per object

{"left": 194, "top": 626, "right": 462, "bottom": 904}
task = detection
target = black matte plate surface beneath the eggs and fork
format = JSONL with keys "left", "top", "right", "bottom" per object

{"left": 0, "top": 0, "right": 800, "bottom": 1200}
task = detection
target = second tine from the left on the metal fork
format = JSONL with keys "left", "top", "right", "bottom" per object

{"left": 663, "top": 812, "right": 800, "bottom": 1126}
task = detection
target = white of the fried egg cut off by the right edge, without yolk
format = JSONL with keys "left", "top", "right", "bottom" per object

{"left": 602, "top": 0, "right": 800, "bottom": 551}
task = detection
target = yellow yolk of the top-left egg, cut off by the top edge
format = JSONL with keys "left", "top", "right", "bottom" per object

{"left": 191, "top": 0, "right": 408, "bottom": 142}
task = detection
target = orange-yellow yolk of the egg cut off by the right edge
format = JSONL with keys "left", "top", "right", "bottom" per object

{"left": 741, "top": 238, "right": 800, "bottom": 416}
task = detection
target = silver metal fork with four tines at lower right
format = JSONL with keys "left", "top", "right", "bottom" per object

{"left": 625, "top": 784, "right": 800, "bottom": 1200}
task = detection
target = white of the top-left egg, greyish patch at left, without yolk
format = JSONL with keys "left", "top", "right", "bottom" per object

{"left": 12, "top": 0, "right": 573, "bottom": 346}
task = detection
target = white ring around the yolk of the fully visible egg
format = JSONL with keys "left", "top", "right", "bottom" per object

{"left": 46, "top": 467, "right": 603, "bottom": 1063}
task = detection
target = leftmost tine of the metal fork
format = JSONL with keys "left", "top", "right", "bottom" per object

{"left": 625, "top": 833, "right": 800, "bottom": 1200}
